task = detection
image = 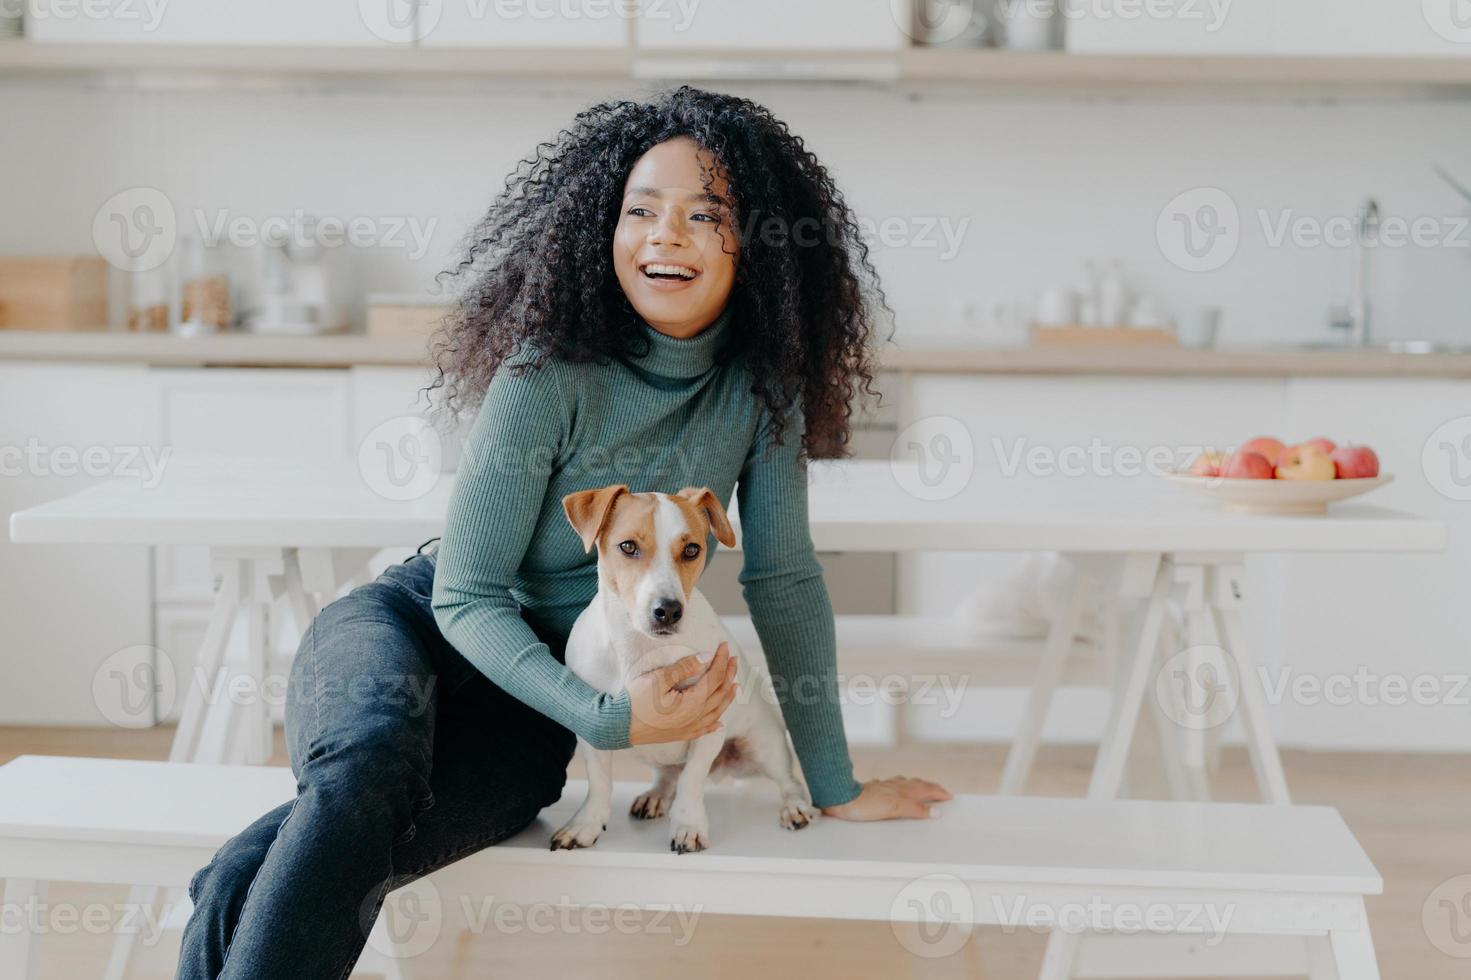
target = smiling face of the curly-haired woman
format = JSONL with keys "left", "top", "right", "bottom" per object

{"left": 613, "top": 137, "right": 738, "bottom": 338}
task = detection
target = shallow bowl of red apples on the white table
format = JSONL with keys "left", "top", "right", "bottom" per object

{"left": 1168, "top": 436, "right": 1393, "bottom": 514}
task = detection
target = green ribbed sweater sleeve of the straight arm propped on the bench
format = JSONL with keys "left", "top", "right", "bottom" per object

{"left": 736, "top": 409, "right": 862, "bottom": 806}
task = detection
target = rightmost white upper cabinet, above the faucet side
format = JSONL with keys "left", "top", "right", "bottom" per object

{"left": 1065, "top": 0, "right": 1471, "bottom": 57}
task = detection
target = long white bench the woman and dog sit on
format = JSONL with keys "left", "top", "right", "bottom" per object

{"left": 0, "top": 756, "right": 1381, "bottom": 980}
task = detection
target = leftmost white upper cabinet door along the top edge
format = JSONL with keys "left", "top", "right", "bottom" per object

{"left": 25, "top": 0, "right": 420, "bottom": 46}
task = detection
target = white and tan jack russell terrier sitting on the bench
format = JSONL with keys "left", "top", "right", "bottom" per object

{"left": 552, "top": 484, "right": 818, "bottom": 853}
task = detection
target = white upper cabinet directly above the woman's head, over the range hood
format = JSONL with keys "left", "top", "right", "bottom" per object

{"left": 637, "top": 0, "right": 909, "bottom": 52}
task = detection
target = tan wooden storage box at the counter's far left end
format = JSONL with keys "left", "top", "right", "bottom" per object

{"left": 0, "top": 258, "right": 107, "bottom": 330}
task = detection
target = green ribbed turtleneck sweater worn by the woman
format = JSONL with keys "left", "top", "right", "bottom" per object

{"left": 434, "top": 310, "right": 859, "bottom": 806}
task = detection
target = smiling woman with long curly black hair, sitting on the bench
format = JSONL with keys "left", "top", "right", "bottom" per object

{"left": 178, "top": 88, "right": 949, "bottom": 980}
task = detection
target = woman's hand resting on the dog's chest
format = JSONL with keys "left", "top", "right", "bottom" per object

{"left": 628, "top": 643, "right": 740, "bottom": 745}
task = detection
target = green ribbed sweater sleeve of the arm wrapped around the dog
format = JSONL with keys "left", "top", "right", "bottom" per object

{"left": 432, "top": 362, "right": 630, "bottom": 749}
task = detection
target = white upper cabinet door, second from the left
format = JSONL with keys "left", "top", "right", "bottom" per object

{"left": 423, "top": 0, "right": 635, "bottom": 50}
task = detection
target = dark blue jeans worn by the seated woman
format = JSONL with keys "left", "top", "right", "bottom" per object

{"left": 178, "top": 547, "right": 577, "bottom": 980}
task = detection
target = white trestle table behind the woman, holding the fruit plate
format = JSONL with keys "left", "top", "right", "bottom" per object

{"left": 10, "top": 461, "right": 1445, "bottom": 803}
